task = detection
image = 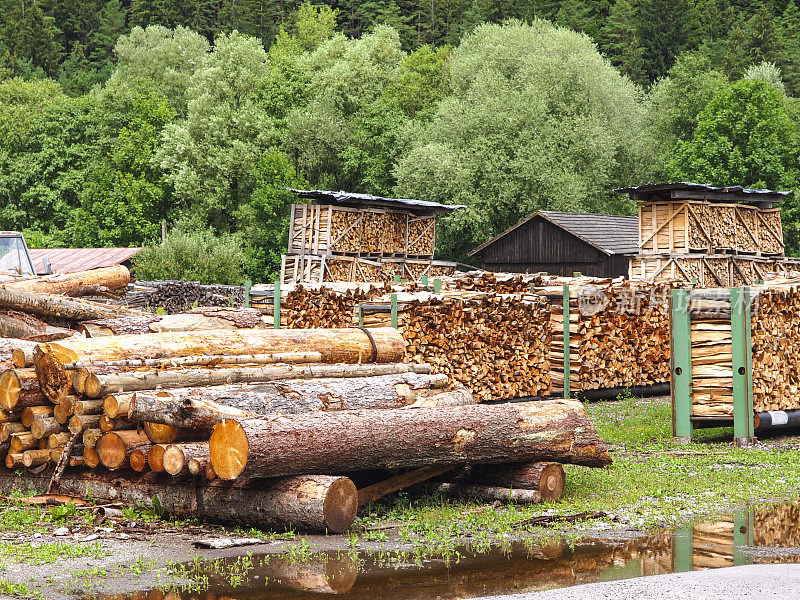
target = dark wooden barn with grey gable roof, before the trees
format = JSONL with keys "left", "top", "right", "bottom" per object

{"left": 470, "top": 210, "right": 639, "bottom": 277}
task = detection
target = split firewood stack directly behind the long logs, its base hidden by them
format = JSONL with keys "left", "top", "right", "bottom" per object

{"left": 361, "top": 291, "right": 550, "bottom": 401}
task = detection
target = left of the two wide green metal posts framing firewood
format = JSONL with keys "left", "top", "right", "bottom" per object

{"left": 670, "top": 289, "right": 692, "bottom": 443}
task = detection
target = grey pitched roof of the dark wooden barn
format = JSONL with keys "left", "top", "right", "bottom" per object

{"left": 469, "top": 210, "right": 639, "bottom": 256}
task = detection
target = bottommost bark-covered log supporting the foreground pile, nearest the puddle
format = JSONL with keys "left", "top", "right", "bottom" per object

{"left": 0, "top": 469, "right": 358, "bottom": 533}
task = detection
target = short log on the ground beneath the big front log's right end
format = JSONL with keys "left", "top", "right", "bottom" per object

{"left": 463, "top": 463, "right": 566, "bottom": 501}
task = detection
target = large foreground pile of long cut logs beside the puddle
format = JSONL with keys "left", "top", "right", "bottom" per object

{"left": 0, "top": 328, "right": 610, "bottom": 532}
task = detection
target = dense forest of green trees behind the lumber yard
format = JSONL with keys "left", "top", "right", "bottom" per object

{"left": 0, "top": 0, "right": 800, "bottom": 282}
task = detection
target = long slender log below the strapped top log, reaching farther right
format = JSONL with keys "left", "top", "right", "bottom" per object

{"left": 82, "top": 363, "right": 430, "bottom": 398}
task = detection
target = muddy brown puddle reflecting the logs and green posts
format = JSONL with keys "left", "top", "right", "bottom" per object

{"left": 91, "top": 503, "right": 800, "bottom": 600}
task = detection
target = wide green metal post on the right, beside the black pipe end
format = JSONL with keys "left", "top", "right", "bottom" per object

{"left": 731, "top": 287, "right": 755, "bottom": 446}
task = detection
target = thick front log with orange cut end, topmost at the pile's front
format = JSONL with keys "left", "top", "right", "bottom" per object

{"left": 210, "top": 400, "right": 611, "bottom": 479}
